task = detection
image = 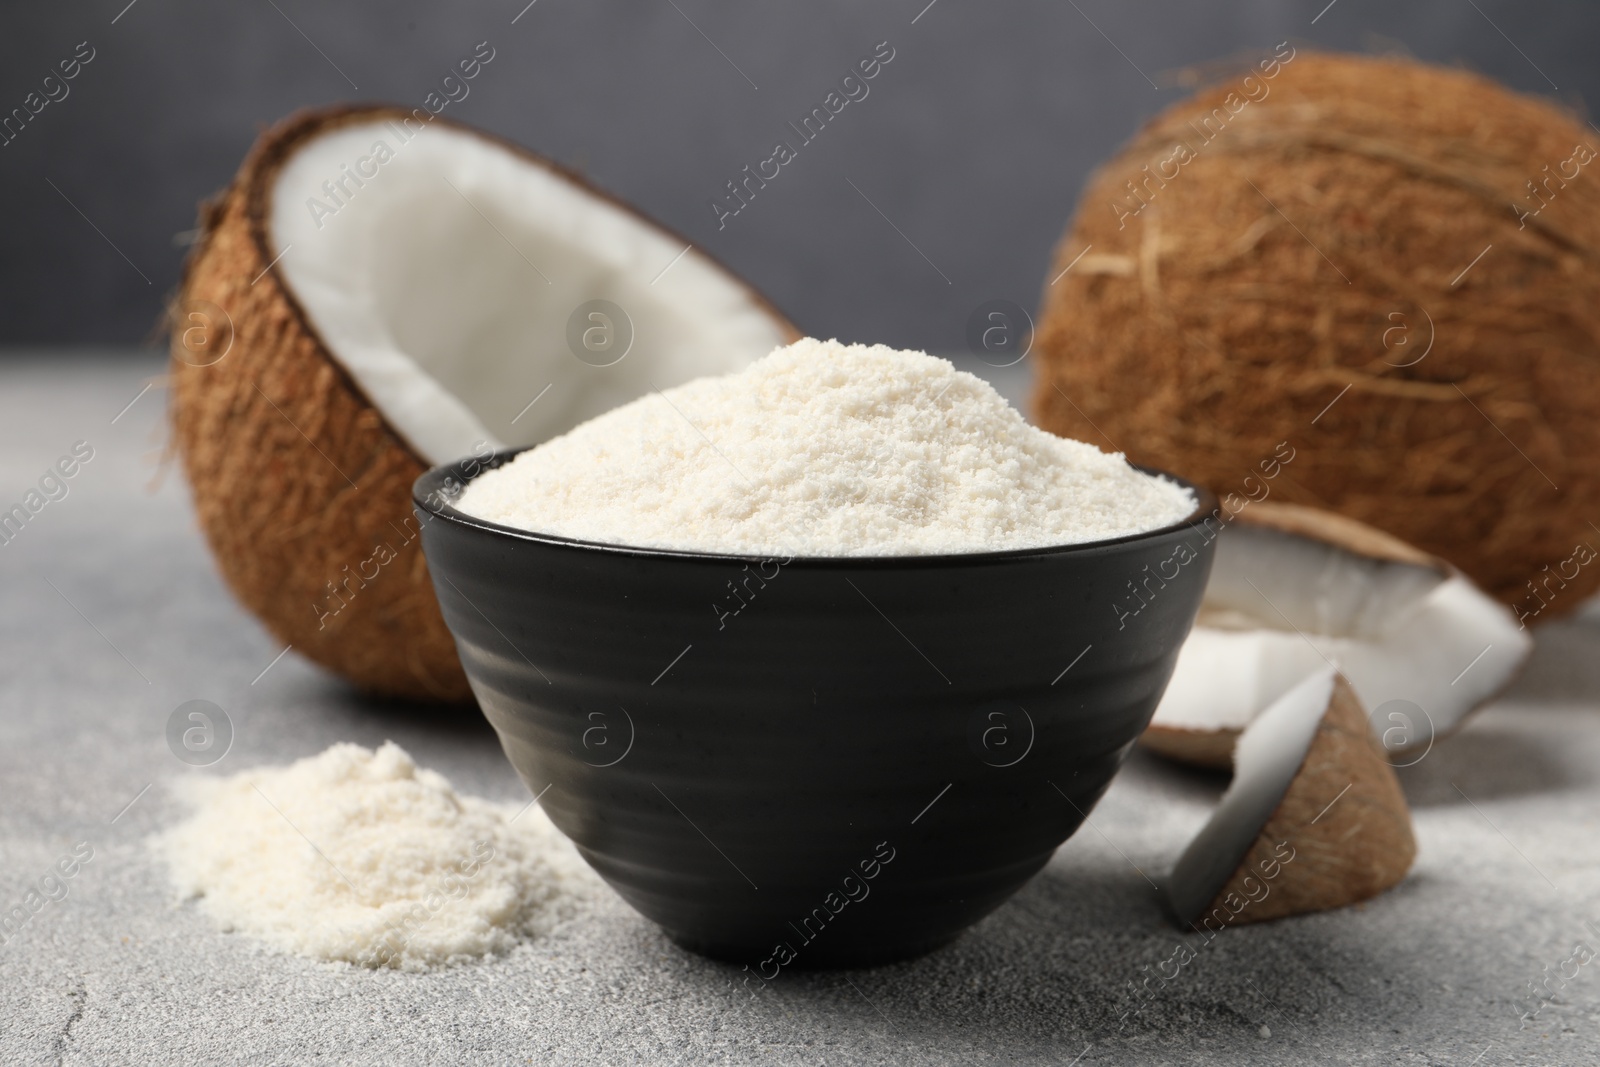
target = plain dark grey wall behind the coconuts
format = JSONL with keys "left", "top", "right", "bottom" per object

{"left": 0, "top": 0, "right": 1600, "bottom": 350}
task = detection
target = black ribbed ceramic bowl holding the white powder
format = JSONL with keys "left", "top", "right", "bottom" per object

{"left": 413, "top": 451, "right": 1216, "bottom": 977}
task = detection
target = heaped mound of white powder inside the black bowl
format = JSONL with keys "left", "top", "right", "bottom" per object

{"left": 456, "top": 339, "right": 1195, "bottom": 557}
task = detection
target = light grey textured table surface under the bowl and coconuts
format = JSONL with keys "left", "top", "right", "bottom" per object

{"left": 0, "top": 352, "right": 1600, "bottom": 1067}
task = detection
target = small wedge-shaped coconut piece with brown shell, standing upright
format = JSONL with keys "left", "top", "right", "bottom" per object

{"left": 1166, "top": 667, "right": 1416, "bottom": 933}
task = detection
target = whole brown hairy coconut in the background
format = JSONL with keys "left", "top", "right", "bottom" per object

{"left": 1034, "top": 53, "right": 1600, "bottom": 621}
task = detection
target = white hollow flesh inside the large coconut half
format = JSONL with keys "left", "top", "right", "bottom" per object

{"left": 267, "top": 120, "right": 789, "bottom": 464}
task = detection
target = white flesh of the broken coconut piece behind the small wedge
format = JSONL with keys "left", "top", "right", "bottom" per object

{"left": 1152, "top": 523, "right": 1533, "bottom": 753}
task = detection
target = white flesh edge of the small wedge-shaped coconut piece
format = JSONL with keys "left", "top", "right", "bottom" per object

{"left": 1166, "top": 665, "right": 1336, "bottom": 926}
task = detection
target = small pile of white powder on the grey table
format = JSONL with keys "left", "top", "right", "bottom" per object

{"left": 154, "top": 742, "right": 598, "bottom": 971}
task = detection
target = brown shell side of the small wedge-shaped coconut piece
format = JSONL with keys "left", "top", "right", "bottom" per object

{"left": 1206, "top": 675, "right": 1416, "bottom": 923}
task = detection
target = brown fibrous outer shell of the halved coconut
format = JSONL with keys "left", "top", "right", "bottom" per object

{"left": 171, "top": 107, "right": 470, "bottom": 701}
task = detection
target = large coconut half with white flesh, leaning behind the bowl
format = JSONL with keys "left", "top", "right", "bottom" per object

{"left": 171, "top": 107, "right": 797, "bottom": 699}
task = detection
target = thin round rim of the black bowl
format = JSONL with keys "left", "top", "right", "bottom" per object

{"left": 411, "top": 445, "right": 1229, "bottom": 569}
